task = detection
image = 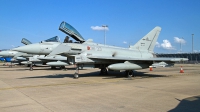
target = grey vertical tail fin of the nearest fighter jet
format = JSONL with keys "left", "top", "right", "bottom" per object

{"left": 130, "top": 26, "right": 161, "bottom": 52}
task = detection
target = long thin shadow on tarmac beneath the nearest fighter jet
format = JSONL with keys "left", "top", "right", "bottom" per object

{"left": 20, "top": 71, "right": 167, "bottom": 79}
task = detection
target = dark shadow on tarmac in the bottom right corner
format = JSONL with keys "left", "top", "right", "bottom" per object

{"left": 169, "top": 95, "right": 200, "bottom": 112}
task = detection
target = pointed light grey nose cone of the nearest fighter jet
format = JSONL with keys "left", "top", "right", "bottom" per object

{"left": 12, "top": 44, "right": 40, "bottom": 54}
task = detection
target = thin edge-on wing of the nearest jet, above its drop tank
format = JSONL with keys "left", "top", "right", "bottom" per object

{"left": 88, "top": 56, "right": 188, "bottom": 62}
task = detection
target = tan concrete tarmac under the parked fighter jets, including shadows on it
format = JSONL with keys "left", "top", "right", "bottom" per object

{"left": 0, "top": 63, "right": 200, "bottom": 112}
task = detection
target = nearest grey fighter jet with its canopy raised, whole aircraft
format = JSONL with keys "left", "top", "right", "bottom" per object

{"left": 12, "top": 22, "right": 188, "bottom": 78}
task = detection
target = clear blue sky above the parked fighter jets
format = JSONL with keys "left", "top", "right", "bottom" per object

{"left": 0, "top": 0, "right": 200, "bottom": 53}
